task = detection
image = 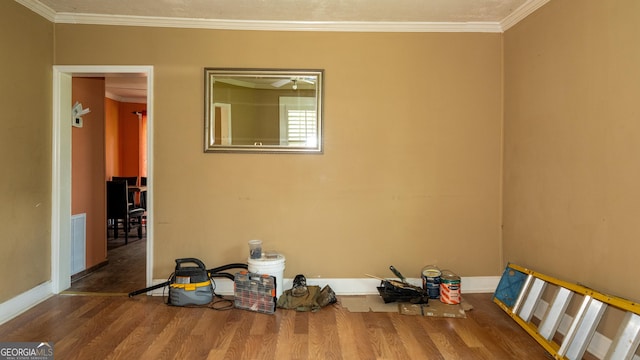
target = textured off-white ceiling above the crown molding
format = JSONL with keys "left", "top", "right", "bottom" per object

{"left": 33, "top": 0, "right": 531, "bottom": 22}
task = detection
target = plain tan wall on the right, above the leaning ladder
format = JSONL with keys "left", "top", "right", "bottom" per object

{"left": 503, "top": 0, "right": 640, "bottom": 300}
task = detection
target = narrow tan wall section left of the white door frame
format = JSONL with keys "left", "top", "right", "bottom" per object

{"left": 0, "top": 1, "right": 53, "bottom": 303}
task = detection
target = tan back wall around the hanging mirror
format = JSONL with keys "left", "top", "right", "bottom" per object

{"left": 56, "top": 24, "right": 503, "bottom": 278}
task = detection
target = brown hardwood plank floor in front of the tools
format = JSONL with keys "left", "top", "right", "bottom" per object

{"left": 0, "top": 294, "right": 550, "bottom": 360}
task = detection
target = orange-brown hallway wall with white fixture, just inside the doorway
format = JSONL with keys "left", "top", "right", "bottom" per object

{"left": 70, "top": 78, "right": 107, "bottom": 268}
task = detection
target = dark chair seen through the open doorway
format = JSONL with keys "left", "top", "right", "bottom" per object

{"left": 107, "top": 181, "right": 144, "bottom": 244}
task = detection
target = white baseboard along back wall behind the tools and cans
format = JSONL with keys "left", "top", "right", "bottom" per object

{"left": 151, "top": 276, "right": 500, "bottom": 296}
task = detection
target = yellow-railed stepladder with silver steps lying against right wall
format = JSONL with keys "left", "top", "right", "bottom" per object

{"left": 493, "top": 264, "right": 640, "bottom": 360}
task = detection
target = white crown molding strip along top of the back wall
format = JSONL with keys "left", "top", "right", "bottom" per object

{"left": 53, "top": 12, "right": 502, "bottom": 32}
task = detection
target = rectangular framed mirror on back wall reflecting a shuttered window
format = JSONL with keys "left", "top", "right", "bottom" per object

{"left": 204, "top": 68, "right": 323, "bottom": 153}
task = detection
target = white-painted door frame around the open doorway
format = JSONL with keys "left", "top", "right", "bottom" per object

{"left": 51, "top": 65, "right": 153, "bottom": 294}
